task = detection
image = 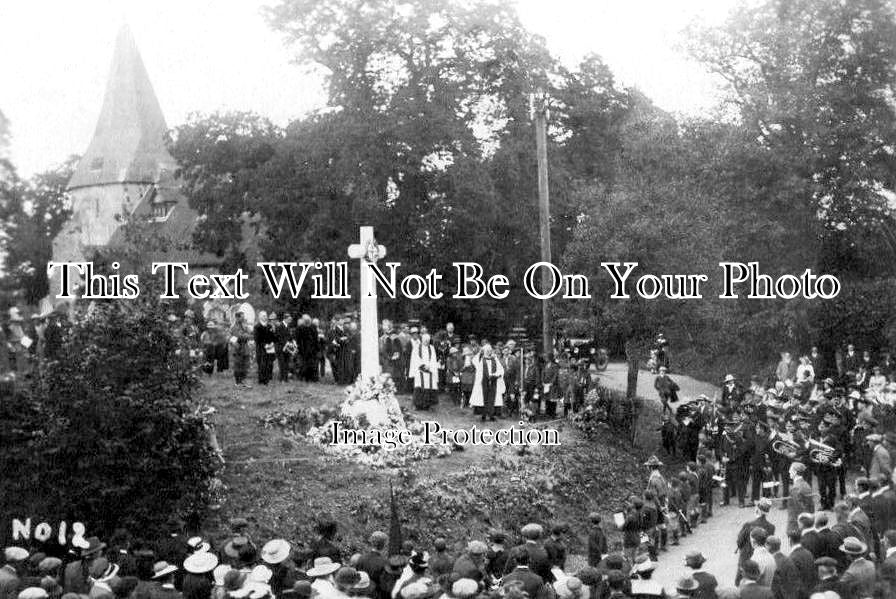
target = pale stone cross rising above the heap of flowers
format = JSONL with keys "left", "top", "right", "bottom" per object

{"left": 348, "top": 227, "right": 386, "bottom": 379}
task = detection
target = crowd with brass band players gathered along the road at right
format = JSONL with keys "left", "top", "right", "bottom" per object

{"left": 625, "top": 345, "right": 896, "bottom": 599}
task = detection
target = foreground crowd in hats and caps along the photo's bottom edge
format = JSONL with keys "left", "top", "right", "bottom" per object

{"left": 0, "top": 506, "right": 720, "bottom": 599}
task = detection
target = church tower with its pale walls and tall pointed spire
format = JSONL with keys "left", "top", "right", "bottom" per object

{"left": 51, "top": 26, "right": 196, "bottom": 282}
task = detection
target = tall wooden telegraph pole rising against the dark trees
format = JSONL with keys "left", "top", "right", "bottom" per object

{"left": 529, "top": 90, "right": 554, "bottom": 358}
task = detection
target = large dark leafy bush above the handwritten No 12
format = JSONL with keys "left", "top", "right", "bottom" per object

{"left": 0, "top": 298, "right": 216, "bottom": 535}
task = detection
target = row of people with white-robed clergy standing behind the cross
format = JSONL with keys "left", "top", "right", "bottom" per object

{"left": 164, "top": 310, "right": 605, "bottom": 420}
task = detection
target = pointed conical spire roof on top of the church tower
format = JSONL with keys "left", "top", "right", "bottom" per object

{"left": 68, "top": 25, "right": 177, "bottom": 189}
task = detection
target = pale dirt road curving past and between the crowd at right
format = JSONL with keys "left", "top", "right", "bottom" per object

{"left": 602, "top": 363, "right": 787, "bottom": 596}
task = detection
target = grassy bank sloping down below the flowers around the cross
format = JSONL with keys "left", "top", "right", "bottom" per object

{"left": 200, "top": 373, "right": 672, "bottom": 560}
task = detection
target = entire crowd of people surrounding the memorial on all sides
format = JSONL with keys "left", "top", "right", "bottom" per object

{"left": 8, "top": 302, "right": 896, "bottom": 599}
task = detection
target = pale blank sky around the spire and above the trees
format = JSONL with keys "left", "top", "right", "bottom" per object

{"left": 0, "top": 0, "right": 737, "bottom": 176}
